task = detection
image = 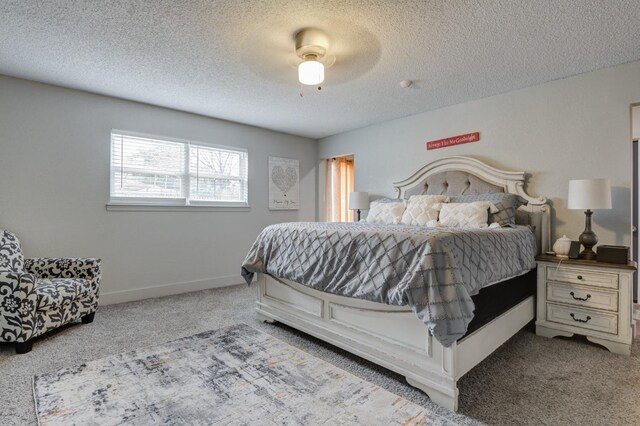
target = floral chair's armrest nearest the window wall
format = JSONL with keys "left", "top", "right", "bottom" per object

{"left": 24, "top": 257, "right": 100, "bottom": 282}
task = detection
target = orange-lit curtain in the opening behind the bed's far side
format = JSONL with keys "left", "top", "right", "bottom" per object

{"left": 324, "top": 157, "right": 354, "bottom": 222}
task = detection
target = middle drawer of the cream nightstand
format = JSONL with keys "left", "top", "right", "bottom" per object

{"left": 547, "top": 282, "right": 618, "bottom": 312}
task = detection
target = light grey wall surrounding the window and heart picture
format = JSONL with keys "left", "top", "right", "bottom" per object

{"left": 0, "top": 76, "right": 317, "bottom": 302}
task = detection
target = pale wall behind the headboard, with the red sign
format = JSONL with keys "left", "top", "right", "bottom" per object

{"left": 319, "top": 62, "right": 640, "bottom": 245}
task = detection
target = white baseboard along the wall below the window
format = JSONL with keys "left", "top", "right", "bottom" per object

{"left": 100, "top": 275, "right": 246, "bottom": 306}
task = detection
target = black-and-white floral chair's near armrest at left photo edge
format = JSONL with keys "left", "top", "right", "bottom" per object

{"left": 0, "top": 271, "right": 38, "bottom": 342}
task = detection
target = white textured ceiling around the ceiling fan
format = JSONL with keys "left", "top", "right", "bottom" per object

{"left": 0, "top": 0, "right": 640, "bottom": 138}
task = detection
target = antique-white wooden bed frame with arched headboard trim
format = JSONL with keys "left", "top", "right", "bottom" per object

{"left": 256, "top": 157, "right": 550, "bottom": 411}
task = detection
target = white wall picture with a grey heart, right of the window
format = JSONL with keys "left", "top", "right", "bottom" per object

{"left": 269, "top": 157, "right": 300, "bottom": 210}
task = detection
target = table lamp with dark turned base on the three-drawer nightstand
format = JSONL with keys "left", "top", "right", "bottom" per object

{"left": 567, "top": 178, "right": 611, "bottom": 260}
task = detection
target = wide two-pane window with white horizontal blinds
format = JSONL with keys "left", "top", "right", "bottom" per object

{"left": 110, "top": 131, "right": 248, "bottom": 206}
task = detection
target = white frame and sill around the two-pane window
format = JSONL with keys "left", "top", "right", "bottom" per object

{"left": 106, "top": 129, "right": 250, "bottom": 211}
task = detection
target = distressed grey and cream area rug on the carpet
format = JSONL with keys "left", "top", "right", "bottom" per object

{"left": 33, "top": 324, "right": 454, "bottom": 425}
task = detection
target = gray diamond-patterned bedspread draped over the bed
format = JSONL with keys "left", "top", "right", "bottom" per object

{"left": 242, "top": 222, "right": 536, "bottom": 346}
